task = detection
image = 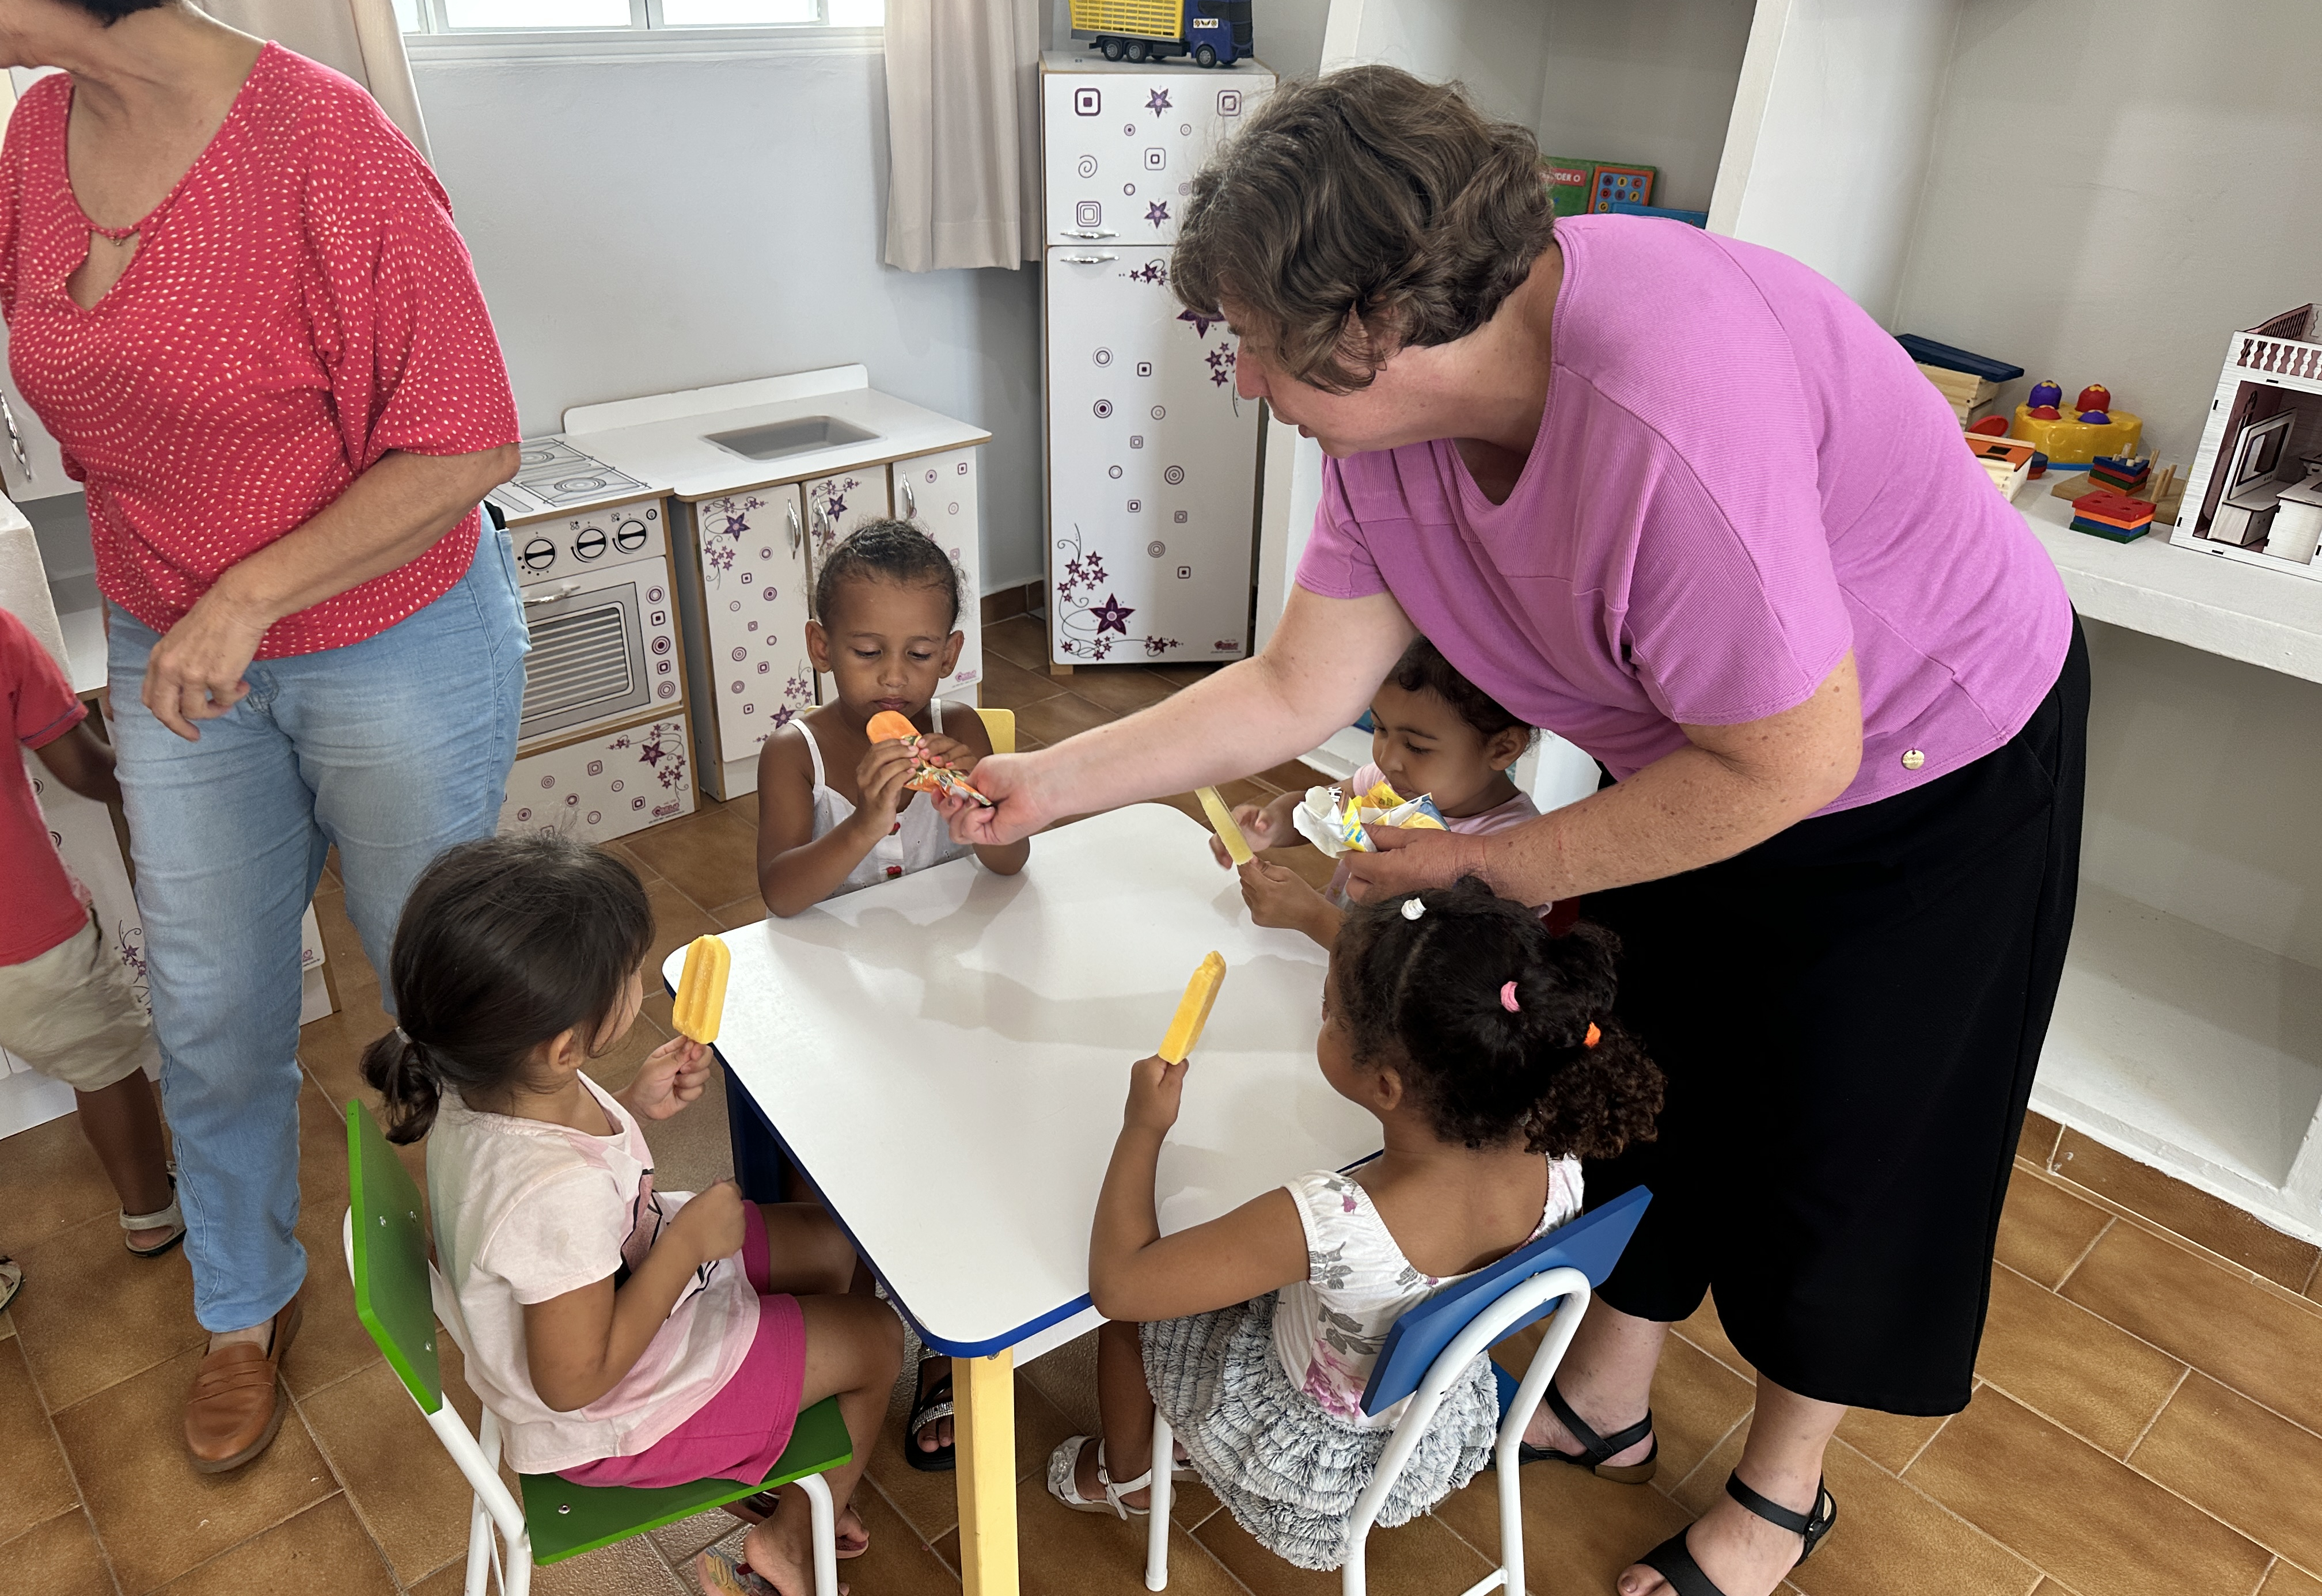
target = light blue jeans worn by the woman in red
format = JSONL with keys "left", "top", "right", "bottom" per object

{"left": 109, "top": 535, "right": 527, "bottom": 1332}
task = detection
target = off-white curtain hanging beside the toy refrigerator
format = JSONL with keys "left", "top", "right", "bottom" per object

{"left": 887, "top": 0, "right": 1040, "bottom": 271}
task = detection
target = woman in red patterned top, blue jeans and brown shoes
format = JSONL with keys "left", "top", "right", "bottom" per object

{"left": 0, "top": 0, "right": 525, "bottom": 1470}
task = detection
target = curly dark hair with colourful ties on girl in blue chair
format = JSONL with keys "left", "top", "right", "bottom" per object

{"left": 1333, "top": 877, "right": 1663, "bottom": 1158}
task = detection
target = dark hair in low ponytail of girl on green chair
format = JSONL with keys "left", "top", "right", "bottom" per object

{"left": 362, "top": 833, "right": 652, "bottom": 1141}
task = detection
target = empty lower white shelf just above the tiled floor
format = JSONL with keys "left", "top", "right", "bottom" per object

{"left": 2032, "top": 886, "right": 2322, "bottom": 1241}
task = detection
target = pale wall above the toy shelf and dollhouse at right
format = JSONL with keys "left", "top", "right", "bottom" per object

{"left": 1897, "top": 0, "right": 2322, "bottom": 464}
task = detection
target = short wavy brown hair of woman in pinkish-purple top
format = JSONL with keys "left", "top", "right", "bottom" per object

{"left": 1170, "top": 67, "right": 1555, "bottom": 392}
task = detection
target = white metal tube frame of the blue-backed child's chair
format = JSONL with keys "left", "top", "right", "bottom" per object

{"left": 1133, "top": 1267, "right": 1591, "bottom": 1596}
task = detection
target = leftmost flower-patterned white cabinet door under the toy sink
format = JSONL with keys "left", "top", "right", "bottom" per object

{"left": 692, "top": 482, "right": 815, "bottom": 798}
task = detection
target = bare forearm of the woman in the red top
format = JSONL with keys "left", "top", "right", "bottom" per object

{"left": 211, "top": 443, "right": 518, "bottom": 626}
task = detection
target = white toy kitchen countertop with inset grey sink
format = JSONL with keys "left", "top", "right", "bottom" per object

{"left": 543, "top": 367, "right": 992, "bottom": 512}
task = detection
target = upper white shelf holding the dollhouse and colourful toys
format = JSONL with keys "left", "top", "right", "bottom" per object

{"left": 2016, "top": 478, "right": 2322, "bottom": 682}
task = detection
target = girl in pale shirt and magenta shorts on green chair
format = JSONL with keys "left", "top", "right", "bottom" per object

{"left": 362, "top": 835, "right": 903, "bottom": 1596}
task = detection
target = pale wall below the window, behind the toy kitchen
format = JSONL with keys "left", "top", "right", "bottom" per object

{"left": 413, "top": 51, "right": 1040, "bottom": 589}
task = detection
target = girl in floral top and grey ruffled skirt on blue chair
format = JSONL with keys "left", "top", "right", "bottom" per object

{"left": 1047, "top": 879, "right": 1660, "bottom": 1568}
